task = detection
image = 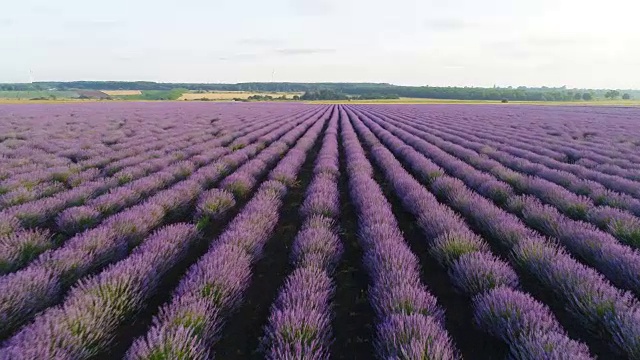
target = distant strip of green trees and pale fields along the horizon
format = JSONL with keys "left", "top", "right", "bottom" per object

{"left": 0, "top": 81, "right": 640, "bottom": 101}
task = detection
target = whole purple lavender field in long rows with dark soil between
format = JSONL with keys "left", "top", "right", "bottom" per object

{"left": 0, "top": 102, "right": 640, "bottom": 360}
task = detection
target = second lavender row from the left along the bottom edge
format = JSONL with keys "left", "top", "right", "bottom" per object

{"left": 127, "top": 105, "right": 326, "bottom": 359}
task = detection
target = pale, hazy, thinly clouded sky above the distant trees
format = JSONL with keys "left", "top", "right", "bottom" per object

{"left": 0, "top": 0, "right": 640, "bottom": 89}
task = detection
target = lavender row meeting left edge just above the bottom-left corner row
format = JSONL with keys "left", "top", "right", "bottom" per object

{"left": 0, "top": 104, "right": 317, "bottom": 344}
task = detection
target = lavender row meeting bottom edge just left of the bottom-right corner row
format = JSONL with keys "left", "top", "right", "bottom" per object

{"left": 349, "top": 106, "right": 590, "bottom": 359}
